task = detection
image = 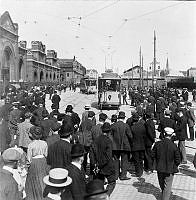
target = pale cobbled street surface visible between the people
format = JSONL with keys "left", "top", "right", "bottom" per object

{"left": 46, "top": 90, "right": 196, "bottom": 200}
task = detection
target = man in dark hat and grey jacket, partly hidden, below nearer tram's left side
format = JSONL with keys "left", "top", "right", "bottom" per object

{"left": 91, "top": 113, "right": 107, "bottom": 141}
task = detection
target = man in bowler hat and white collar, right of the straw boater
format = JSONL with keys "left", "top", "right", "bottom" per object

{"left": 66, "top": 144, "right": 86, "bottom": 200}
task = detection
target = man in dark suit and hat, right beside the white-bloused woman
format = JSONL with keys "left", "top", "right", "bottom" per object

{"left": 47, "top": 125, "right": 73, "bottom": 169}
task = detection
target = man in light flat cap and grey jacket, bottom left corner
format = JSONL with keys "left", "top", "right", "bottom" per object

{"left": 0, "top": 148, "right": 22, "bottom": 200}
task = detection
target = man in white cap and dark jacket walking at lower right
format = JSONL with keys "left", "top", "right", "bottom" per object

{"left": 152, "top": 127, "right": 180, "bottom": 200}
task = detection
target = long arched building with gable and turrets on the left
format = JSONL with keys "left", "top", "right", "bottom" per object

{"left": 0, "top": 11, "right": 60, "bottom": 93}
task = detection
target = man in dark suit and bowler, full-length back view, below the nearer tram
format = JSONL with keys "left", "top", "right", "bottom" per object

{"left": 111, "top": 111, "right": 132, "bottom": 180}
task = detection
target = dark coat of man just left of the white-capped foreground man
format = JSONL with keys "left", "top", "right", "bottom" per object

{"left": 145, "top": 119, "right": 156, "bottom": 147}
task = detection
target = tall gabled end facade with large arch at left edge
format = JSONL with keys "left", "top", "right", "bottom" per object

{"left": 0, "top": 11, "right": 26, "bottom": 93}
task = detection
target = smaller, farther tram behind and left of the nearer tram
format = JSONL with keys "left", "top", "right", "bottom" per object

{"left": 80, "top": 76, "right": 97, "bottom": 94}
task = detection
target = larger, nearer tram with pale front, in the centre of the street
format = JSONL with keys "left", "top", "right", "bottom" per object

{"left": 98, "top": 70, "right": 121, "bottom": 110}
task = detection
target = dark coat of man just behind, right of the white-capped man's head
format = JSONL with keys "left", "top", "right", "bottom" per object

{"left": 176, "top": 116, "right": 188, "bottom": 141}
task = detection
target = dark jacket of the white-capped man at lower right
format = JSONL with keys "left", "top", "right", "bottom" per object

{"left": 152, "top": 138, "right": 180, "bottom": 174}
